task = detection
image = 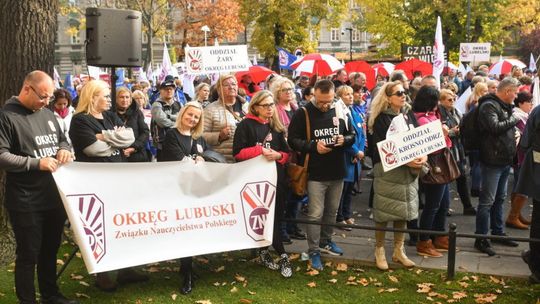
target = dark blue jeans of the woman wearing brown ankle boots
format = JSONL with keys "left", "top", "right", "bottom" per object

{"left": 419, "top": 184, "right": 450, "bottom": 241}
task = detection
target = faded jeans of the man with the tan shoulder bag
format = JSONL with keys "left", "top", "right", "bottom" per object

{"left": 306, "top": 179, "right": 343, "bottom": 253}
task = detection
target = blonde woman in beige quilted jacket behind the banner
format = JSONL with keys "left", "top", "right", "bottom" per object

{"left": 203, "top": 74, "right": 245, "bottom": 163}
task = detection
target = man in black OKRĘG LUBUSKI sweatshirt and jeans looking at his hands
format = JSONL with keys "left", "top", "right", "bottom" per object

{"left": 288, "top": 80, "right": 355, "bottom": 270}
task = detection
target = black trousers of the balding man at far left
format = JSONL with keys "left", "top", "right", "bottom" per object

{"left": 9, "top": 208, "right": 66, "bottom": 304}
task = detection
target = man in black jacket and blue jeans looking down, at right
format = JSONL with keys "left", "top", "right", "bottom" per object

{"left": 474, "top": 77, "right": 519, "bottom": 256}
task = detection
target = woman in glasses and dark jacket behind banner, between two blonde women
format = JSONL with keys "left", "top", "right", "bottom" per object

{"left": 116, "top": 87, "right": 150, "bottom": 162}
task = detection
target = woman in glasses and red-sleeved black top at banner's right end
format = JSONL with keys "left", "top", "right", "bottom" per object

{"left": 233, "top": 90, "right": 292, "bottom": 278}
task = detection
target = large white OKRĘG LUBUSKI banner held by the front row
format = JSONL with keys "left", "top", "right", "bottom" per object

{"left": 53, "top": 157, "right": 277, "bottom": 273}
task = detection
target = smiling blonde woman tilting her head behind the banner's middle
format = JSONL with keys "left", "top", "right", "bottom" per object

{"left": 161, "top": 101, "right": 209, "bottom": 294}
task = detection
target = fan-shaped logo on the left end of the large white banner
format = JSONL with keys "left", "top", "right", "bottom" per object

{"left": 67, "top": 194, "right": 106, "bottom": 263}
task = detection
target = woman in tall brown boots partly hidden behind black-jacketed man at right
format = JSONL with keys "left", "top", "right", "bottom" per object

{"left": 506, "top": 91, "right": 533, "bottom": 229}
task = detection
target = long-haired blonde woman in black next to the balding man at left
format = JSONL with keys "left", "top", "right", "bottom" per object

{"left": 69, "top": 80, "right": 148, "bottom": 292}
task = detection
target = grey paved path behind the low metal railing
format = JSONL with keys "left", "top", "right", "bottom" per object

{"left": 286, "top": 173, "right": 532, "bottom": 277}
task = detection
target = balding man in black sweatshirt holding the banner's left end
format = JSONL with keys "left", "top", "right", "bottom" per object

{"left": 0, "top": 71, "right": 78, "bottom": 304}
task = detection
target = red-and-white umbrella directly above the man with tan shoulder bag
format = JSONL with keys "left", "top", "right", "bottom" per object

{"left": 291, "top": 53, "right": 343, "bottom": 76}
